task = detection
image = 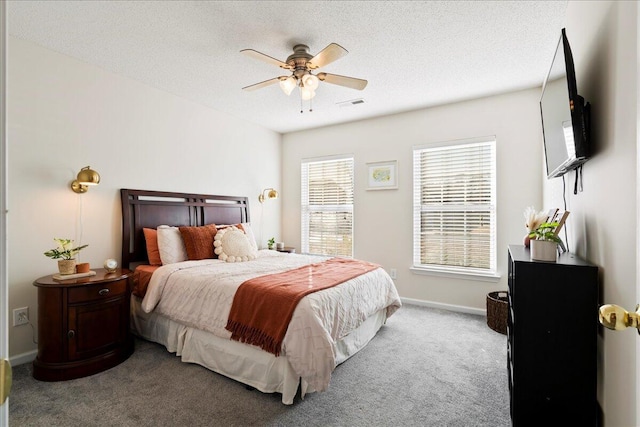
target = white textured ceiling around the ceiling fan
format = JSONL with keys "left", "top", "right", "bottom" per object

{"left": 7, "top": 1, "right": 571, "bottom": 133}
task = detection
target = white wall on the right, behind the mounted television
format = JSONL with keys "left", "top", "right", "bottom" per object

{"left": 543, "top": 1, "right": 640, "bottom": 427}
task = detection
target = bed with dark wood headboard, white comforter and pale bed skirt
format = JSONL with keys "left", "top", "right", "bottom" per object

{"left": 121, "top": 189, "right": 401, "bottom": 405}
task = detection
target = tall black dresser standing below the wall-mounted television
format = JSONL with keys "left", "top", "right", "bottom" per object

{"left": 507, "top": 246, "right": 598, "bottom": 427}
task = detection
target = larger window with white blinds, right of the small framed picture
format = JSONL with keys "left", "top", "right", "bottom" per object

{"left": 413, "top": 137, "right": 496, "bottom": 277}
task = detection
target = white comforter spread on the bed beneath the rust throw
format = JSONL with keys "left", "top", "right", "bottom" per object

{"left": 142, "top": 250, "right": 401, "bottom": 391}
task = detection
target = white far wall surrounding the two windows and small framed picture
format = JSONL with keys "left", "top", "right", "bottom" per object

{"left": 282, "top": 88, "right": 542, "bottom": 309}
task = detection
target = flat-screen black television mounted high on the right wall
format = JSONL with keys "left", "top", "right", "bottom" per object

{"left": 540, "top": 28, "right": 590, "bottom": 179}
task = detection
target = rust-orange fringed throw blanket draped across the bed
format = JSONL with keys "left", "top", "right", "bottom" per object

{"left": 226, "top": 258, "right": 380, "bottom": 356}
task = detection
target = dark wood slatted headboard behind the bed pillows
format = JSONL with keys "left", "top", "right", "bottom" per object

{"left": 120, "top": 188, "right": 249, "bottom": 268}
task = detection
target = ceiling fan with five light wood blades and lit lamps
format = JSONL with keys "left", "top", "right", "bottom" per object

{"left": 240, "top": 43, "right": 367, "bottom": 108}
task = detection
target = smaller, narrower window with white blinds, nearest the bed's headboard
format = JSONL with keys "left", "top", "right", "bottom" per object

{"left": 301, "top": 156, "right": 353, "bottom": 257}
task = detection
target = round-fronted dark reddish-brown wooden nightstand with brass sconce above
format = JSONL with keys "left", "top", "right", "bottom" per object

{"left": 33, "top": 268, "right": 133, "bottom": 381}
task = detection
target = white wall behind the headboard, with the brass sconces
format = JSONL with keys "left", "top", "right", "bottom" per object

{"left": 3, "top": 37, "right": 281, "bottom": 356}
